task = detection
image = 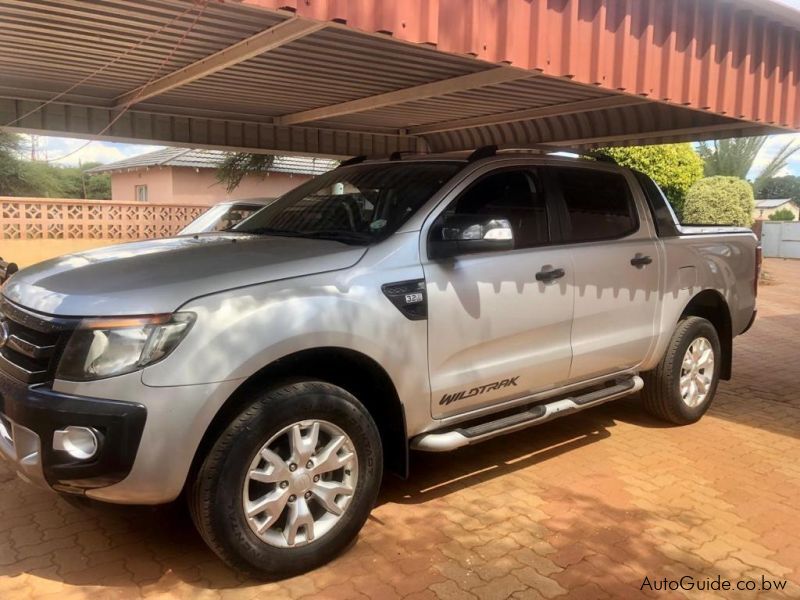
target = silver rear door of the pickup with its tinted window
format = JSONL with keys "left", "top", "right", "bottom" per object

{"left": 548, "top": 166, "right": 662, "bottom": 381}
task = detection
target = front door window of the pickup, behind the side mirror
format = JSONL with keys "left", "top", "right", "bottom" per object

{"left": 448, "top": 169, "right": 549, "bottom": 248}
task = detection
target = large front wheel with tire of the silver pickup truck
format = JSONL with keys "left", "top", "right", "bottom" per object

{"left": 189, "top": 381, "right": 383, "bottom": 579}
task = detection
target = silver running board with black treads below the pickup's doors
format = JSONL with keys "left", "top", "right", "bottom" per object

{"left": 411, "top": 375, "right": 644, "bottom": 452}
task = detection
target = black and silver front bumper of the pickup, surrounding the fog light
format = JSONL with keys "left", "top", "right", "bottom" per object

{"left": 0, "top": 372, "right": 147, "bottom": 494}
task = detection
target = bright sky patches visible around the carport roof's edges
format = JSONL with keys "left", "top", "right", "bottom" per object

{"left": 18, "top": 0, "right": 800, "bottom": 177}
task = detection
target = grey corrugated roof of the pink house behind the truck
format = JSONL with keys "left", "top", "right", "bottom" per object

{"left": 87, "top": 148, "right": 338, "bottom": 175}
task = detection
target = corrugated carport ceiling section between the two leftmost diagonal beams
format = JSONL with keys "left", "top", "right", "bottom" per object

{"left": 152, "top": 29, "right": 489, "bottom": 116}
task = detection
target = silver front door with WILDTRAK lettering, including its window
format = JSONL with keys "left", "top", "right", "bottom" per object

{"left": 423, "top": 167, "right": 574, "bottom": 418}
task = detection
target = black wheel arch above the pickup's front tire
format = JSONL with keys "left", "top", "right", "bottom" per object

{"left": 189, "top": 347, "right": 408, "bottom": 481}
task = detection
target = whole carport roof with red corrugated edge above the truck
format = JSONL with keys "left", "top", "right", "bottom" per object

{"left": 0, "top": 0, "right": 800, "bottom": 156}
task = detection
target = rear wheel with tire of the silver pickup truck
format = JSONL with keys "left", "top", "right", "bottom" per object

{"left": 642, "top": 317, "right": 722, "bottom": 425}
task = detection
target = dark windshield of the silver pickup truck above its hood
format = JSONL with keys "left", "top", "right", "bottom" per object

{"left": 234, "top": 162, "right": 463, "bottom": 244}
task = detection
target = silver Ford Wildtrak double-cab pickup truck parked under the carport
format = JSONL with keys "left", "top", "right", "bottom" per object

{"left": 0, "top": 148, "right": 760, "bottom": 577}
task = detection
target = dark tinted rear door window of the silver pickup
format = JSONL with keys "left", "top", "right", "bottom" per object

{"left": 554, "top": 168, "right": 639, "bottom": 242}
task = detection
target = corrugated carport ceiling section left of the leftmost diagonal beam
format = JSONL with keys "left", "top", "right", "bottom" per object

{"left": 0, "top": 0, "right": 285, "bottom": 98}
